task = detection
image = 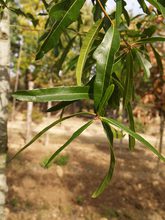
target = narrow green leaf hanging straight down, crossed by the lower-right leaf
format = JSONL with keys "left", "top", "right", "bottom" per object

{"left": 126, "top": 102, "right": 135, "bottom": 150}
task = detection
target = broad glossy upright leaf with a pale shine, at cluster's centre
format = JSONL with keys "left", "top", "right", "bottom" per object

{"left": 94, "top": 26, "right": 120, "bottom": 110}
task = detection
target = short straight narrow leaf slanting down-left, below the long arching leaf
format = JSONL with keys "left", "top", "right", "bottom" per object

{"left": 44, "top": 120, "right": 93, "bottom": 168}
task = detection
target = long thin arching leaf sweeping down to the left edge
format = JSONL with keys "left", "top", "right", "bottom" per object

{"left": 8, "top": 112, "right": 93, "bottom": 162}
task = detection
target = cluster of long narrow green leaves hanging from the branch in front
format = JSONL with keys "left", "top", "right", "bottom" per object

{"left": 2, "top": 0, "right": 165, "bottom": 198}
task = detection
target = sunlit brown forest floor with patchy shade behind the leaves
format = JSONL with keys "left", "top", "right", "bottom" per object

{"left": 7, "top": 116, "right": 165, "bottom": 220}
